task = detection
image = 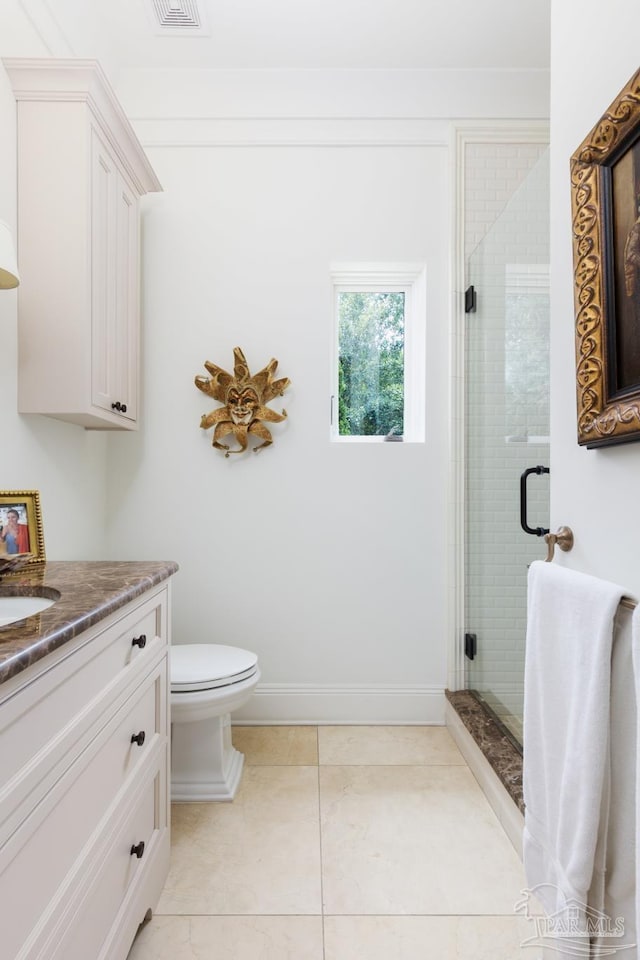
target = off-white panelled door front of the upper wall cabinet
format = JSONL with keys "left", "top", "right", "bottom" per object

{"left": 91, "top": 129, "right": 138, "bottom": 420}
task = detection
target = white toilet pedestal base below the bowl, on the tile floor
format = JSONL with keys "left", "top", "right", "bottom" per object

{"left": 171, "top": 713, "right": 244, "bottom": 803}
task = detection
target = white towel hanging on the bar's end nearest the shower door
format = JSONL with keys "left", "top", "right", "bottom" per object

{"left": 523, "top": 561, "right": 624, "bottom": 928}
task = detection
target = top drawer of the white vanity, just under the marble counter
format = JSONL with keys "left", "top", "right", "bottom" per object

{"left": 0, "top": 591, "right": 167, "bottom": 808}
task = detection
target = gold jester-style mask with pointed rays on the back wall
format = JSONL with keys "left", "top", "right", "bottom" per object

{"left": 195, "top": 347, "right": 291, "bottom": 457}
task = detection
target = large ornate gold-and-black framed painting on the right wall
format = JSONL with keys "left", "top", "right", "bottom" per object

{"left": 571, "top": 70, "right": 640, "bottom": 447}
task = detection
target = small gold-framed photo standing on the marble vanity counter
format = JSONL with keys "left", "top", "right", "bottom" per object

{"left": 0, "top": 490, "right": 45, "bottom": 569}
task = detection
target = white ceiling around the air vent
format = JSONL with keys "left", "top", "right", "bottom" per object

{"left": 28, "top": 0, "right": 550, "bottom": 70}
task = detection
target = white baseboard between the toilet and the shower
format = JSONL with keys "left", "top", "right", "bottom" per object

{"left": 233, "top": 683, "right": 445, "bottom": 726}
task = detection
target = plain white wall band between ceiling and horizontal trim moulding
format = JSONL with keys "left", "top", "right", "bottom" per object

{"left": 117, "top": 69, "right": 549, "bottom": 122}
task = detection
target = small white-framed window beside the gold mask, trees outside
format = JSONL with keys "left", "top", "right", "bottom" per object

{"left": 331, "top": 264, "right": 425, "bottom": 442}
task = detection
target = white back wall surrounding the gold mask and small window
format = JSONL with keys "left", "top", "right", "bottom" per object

{"left": 109, "top": 137, "right": 449, "bottom": 720}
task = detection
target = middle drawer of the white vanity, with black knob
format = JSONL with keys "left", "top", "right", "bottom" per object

{"left": 0, "top": 659, "right": 167, "bottom": 957}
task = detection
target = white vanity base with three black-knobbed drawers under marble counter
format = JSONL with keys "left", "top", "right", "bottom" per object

{"left": 0, "top": 582, "right": 170, "bottom": 960}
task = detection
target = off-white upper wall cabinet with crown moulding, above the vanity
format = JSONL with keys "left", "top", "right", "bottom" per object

{"left": 3, "top": 59, "right": 161, "bottom": 429}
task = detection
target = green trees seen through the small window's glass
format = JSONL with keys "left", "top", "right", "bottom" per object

{"left": 338, "top": 291, "right": 405, "bottom": 436}
